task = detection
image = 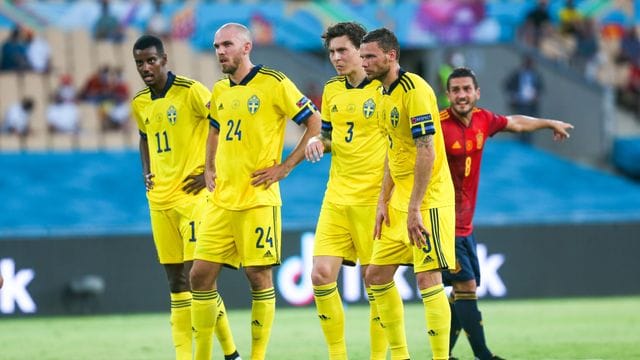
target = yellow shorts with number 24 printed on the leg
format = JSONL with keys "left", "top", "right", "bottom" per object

{"left": 194, "top": 202, "right": 282, "bottom": 268}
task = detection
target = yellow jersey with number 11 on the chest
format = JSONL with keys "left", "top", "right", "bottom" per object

{"left": 131, "top": 72, "right": 211, "bottom": 210}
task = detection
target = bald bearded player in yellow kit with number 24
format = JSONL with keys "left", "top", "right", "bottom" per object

{"left": 191, "top": 23, "right": 320, "bottom": 360}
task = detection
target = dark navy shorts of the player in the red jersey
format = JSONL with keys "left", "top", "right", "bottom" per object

{"left": 442, "top": 234, "right": 480, "bottom": 286}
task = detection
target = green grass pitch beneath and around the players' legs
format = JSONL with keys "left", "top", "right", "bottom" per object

{"left": 0, "top": 297, "right": 640, "bottom": 360}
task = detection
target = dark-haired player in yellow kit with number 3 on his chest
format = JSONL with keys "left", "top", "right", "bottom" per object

{"left": 305, "top": 22, "right": 387, "bottom": 360}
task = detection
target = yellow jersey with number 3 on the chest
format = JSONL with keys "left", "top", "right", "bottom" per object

{"left": 321, "top": 75, "right": 387, "bottom": 205}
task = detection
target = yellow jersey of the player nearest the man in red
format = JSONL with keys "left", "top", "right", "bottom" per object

{"left": 383, "top": 69, "right": 455, "bottom": 212}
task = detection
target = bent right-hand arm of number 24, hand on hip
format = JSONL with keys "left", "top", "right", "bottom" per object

{"left": 251, "top": 112, "right": 321, "bottom": 188}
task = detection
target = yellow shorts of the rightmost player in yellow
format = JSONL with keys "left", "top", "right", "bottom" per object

{"left": 371, "top": 206, "right": 456, "bottom": 273}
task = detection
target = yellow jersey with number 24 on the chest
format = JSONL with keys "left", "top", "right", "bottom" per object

{"left": 209, "top": 65, "right": 318, "bottom": 210}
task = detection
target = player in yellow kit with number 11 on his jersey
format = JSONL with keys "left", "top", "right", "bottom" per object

{"left": 131, "top": 35, "right": 240, "bottom": 360}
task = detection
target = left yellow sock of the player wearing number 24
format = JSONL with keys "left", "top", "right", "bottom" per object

{"left": 191, "top": 290, "right": 218, "bottom": 360}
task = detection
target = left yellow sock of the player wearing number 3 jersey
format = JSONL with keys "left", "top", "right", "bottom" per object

{"left": 313, "top": 282, "right": 347, "bottom": 360}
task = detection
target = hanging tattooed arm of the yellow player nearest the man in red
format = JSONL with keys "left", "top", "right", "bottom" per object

{"left": 407, "top": 135, "right": 436, "bottom": 247}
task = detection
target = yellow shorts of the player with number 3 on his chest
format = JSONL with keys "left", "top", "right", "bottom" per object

{"left": 313, "top": 202, "right": 376, "bottom": 265}
